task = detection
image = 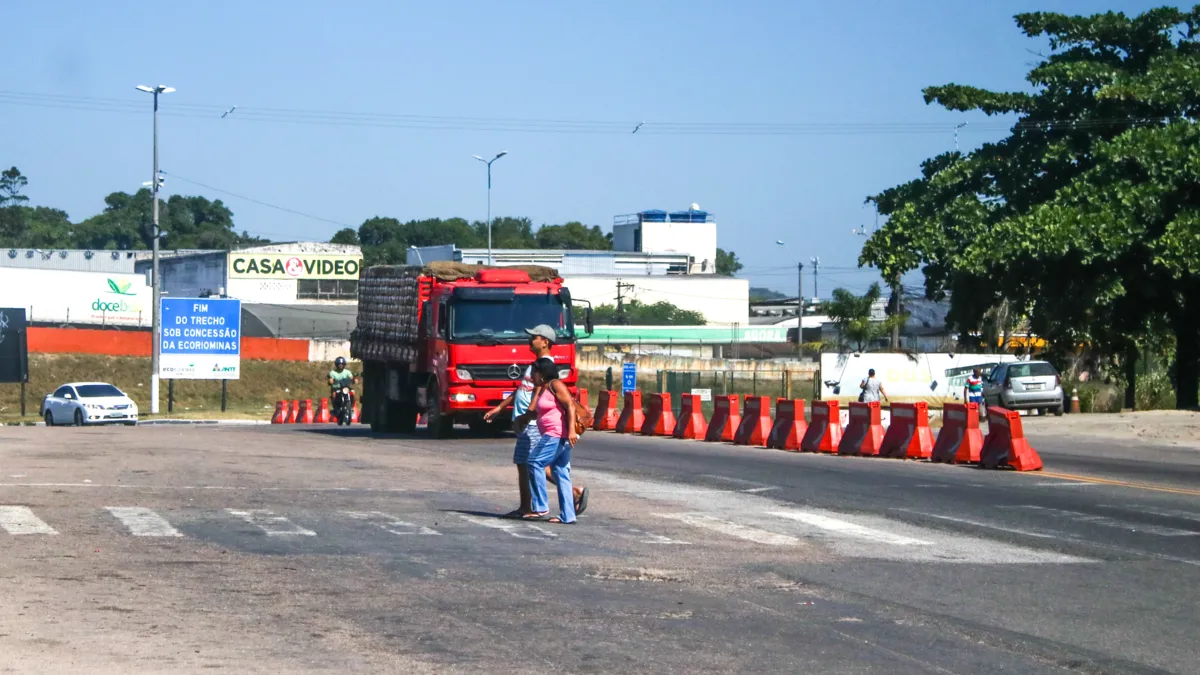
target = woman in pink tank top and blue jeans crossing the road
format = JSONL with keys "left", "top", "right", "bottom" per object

{"left": 518, "top": 360, "right": 580, "bottom": 525}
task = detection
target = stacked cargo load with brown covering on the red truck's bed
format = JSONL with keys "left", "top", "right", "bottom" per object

{"left": 350, "top": 261, "right": 558, "bottom": 363}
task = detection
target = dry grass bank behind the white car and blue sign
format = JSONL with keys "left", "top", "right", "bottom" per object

{"left": 0, "top": 354, "right": 348, "bottom": 420}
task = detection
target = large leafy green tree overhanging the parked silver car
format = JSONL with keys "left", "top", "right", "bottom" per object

{"left": 859, "top": 6, "right": 1200, "bottom": 407}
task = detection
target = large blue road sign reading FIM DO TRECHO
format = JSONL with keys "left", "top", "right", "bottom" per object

{"left": 158, "top": 298, "right": 241, "bottom": 380}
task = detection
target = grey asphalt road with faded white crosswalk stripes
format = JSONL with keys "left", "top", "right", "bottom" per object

{"left": 0, "top": 424, "right": 1200, "bottom": 674}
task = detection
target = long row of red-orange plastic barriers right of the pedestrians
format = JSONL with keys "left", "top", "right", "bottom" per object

{"left": 581, "top": 390, "right": 1042, "bottom": 471}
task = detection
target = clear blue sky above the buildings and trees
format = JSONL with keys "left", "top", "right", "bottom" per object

{"left": 0, "top": 0, "right": 1163, "bottom": 295}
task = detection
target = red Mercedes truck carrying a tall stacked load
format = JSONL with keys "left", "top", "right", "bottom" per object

{"left": 350, "top": 262, "right": 592, "bottom": 438}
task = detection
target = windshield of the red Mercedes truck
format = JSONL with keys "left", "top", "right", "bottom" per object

{"left": 450, "top": 293, "right": 575, "bottom": 342}
